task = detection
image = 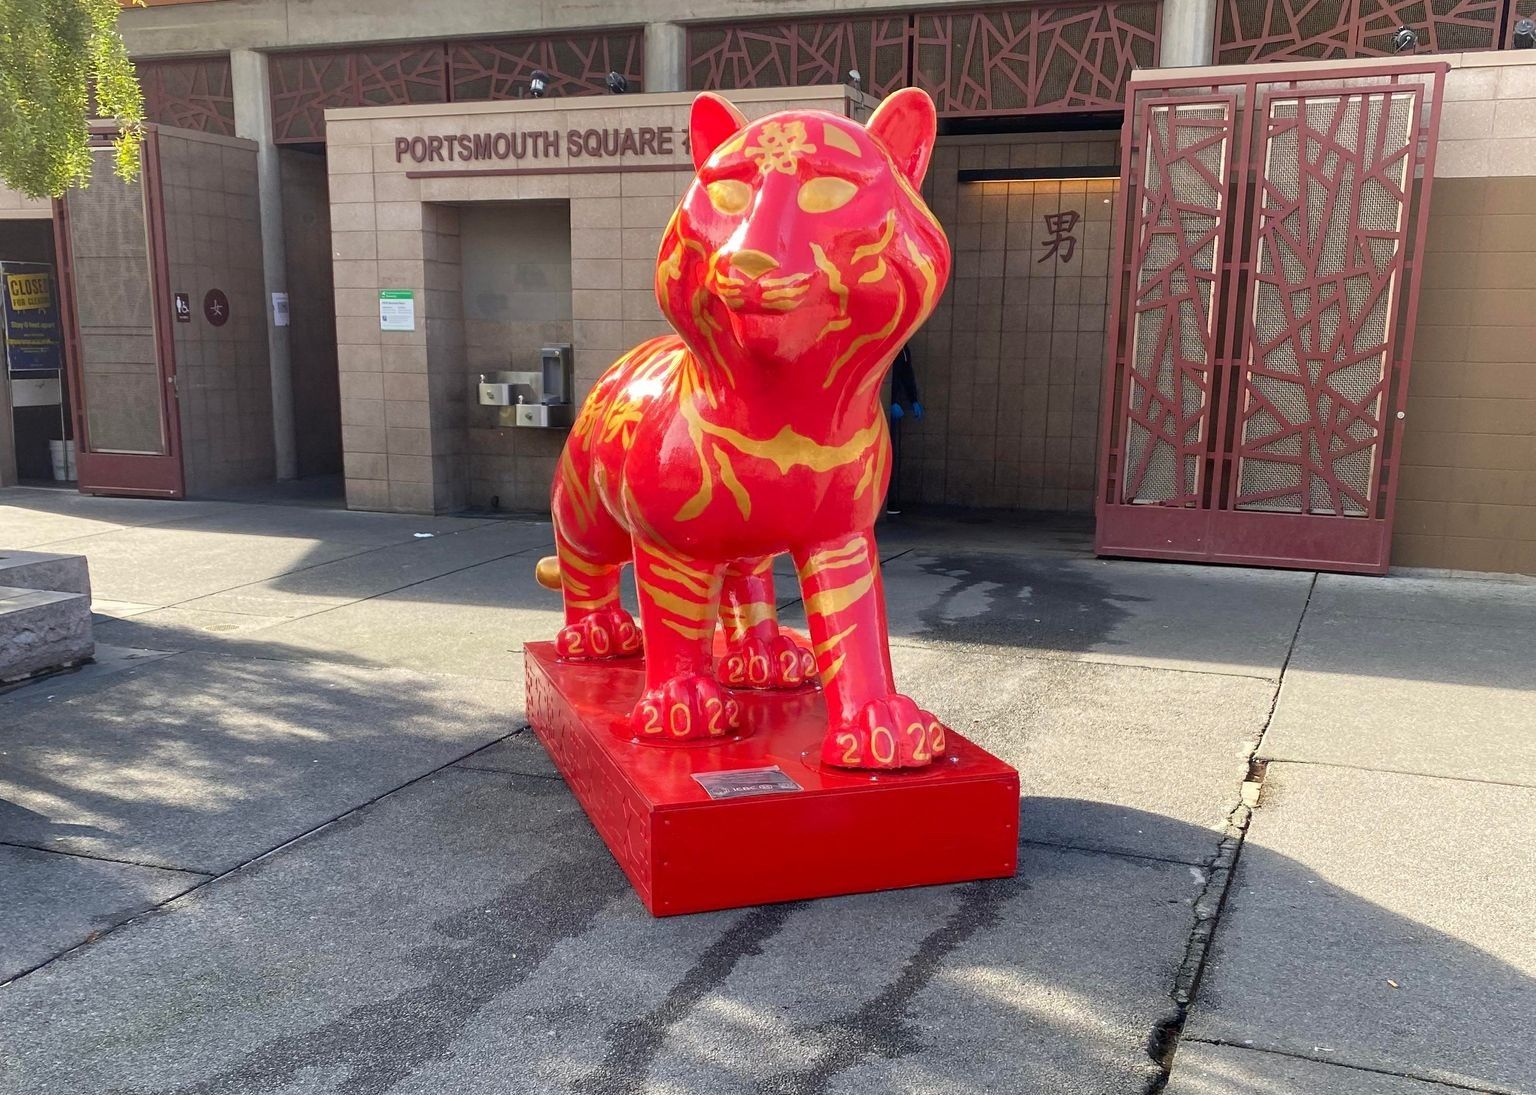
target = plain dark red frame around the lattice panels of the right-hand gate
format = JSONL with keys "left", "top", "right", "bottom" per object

{"left": 1094, "top": 61, "right": 1450, "bottom": 574}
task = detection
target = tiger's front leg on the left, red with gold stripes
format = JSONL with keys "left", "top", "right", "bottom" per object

{"left": 630, "top": 538, "right": 742, "bottom": 742}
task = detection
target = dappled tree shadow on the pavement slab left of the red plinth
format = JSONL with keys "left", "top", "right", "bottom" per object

{"left": 0, "top": 635, "right": 521, "bottom": 874}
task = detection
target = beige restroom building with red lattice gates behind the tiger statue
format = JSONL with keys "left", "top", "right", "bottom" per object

{"left": 0, "top": 0, "right": 1536, "bottom": 574}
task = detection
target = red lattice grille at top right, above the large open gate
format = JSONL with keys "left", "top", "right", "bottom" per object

{"left": 1215, "top": 0, "right": 1510, "bottom": 65}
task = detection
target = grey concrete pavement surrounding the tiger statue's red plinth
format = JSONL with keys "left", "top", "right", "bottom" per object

{"left": 0, "top": 488, "right": 1536, "bottom": 1095}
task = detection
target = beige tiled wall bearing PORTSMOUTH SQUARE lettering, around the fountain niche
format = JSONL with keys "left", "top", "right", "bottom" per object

{"left": 327, "top": 88, "right": 868, "bottom": 513}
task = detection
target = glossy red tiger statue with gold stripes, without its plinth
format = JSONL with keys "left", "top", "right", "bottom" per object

{"left": 539, "top": 88, "right": 949, "bottom": 768}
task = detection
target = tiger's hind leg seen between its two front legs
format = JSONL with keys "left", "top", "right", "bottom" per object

{"left": 719, "top": 556, "right": 816, "bottom": 688}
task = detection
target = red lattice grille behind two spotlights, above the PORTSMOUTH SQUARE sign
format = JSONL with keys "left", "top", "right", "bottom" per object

{"left": 449, "top": 28, "right": 645, "bottom": 103}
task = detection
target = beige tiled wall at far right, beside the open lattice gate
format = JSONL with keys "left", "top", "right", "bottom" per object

{"left": 1392, "top": 54, "right": 1536, "bottom": 574}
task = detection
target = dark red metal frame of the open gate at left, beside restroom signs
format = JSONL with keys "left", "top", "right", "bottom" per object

{"left": 54, "top": 126, "right": 186, "bottom": 498}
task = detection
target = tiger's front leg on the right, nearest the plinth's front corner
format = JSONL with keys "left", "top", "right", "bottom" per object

{"left": 794, "top": 531, "right": 945, "bottom": 768}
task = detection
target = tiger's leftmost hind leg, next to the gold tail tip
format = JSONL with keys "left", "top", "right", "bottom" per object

{"left": 541, "top": 458, "right": 641, "bottom": 662}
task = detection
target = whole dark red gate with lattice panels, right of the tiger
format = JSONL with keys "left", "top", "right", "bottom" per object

{"left": 1095, "top": 61, "right": 1447, "bottom": 574}
